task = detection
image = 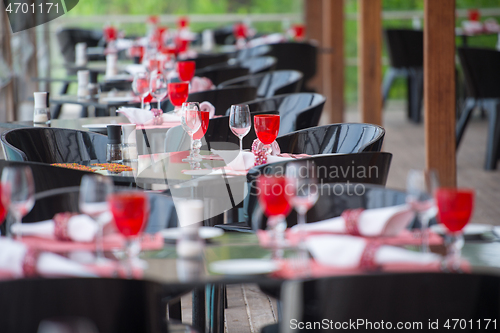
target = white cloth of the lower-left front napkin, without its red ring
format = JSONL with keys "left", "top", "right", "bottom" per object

{"left": 0, "top": 237, "right": 96, "bottom": 277}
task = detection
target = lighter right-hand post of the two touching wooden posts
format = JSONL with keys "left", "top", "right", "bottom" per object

{"left": 322, "top": 0, "right": 344, "bottom": 123}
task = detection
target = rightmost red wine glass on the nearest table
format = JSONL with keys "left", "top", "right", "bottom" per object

{"left": 436, "top": 188, "right": 474, "bottom": 270}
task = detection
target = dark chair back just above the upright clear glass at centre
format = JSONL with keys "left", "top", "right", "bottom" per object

{"left": 188, "top": 86, "right": 257, "bottom": 115}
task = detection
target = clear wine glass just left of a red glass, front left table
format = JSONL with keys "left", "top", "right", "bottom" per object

{"left": 78, "top": 175, "right": 113, "bottom": 263}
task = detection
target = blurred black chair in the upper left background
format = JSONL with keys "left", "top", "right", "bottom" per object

{"left": 56, "top": 28, "right": 103, "bottom": 63}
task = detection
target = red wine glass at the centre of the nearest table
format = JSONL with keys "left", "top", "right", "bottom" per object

{"left": 257, "top": 175, "right": 292, "bottom": 247}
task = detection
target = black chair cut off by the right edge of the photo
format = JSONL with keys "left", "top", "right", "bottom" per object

{"left": 456, "top": 48, "right": 500, "bottom": 170}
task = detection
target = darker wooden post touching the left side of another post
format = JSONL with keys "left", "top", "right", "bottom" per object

{"left": 304, "top": 0, "right": 323, "bottom": 93}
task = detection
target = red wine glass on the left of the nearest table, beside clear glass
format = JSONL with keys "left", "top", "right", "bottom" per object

{"left": 108, "top": 191, "right": 149, "bottom": 276}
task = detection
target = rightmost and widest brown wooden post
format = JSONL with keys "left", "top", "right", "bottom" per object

{"left": 424, "top": 0, "right": 457, "bottom": 186}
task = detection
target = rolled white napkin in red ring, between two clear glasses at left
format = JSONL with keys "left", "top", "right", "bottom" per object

{"left": 12, "top": 213, "right": 99, "bottom": 242}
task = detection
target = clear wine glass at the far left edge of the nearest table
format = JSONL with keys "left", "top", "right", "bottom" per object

{"left": 2, "top": 166, "right": 35, "bottom": 239}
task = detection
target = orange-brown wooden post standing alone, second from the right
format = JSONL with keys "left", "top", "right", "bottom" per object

{"left": 358, "top": 0, "right": 382, "bottom": 125}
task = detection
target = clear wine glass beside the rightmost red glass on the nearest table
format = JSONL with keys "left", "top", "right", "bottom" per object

{"left": 406, "top": 169, "right": 439, "bottom": 253}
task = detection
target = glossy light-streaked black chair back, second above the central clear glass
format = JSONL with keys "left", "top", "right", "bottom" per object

{"left": 219, "top": 70, "right": 303, "bottom": 98}
